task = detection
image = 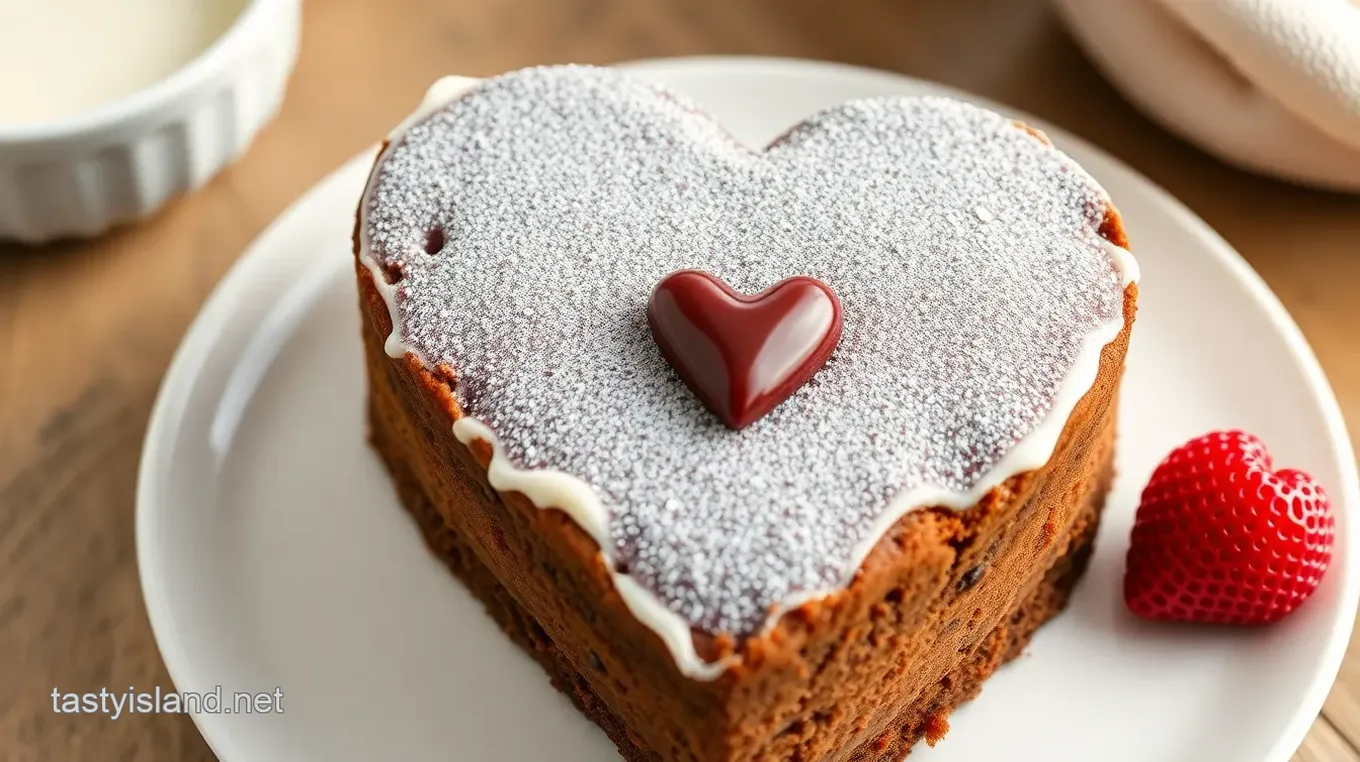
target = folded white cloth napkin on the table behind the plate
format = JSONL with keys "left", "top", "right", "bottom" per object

{"left": 1054, "top": 0, "right": 1360, "bottom": 192}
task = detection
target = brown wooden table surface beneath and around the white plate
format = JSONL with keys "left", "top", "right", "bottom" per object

{"left": 0, "top": 0, "right": 1360, "bottom": 762}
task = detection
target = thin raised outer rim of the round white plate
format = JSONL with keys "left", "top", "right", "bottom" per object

{"left": 133, "top": 54, "right": 1360, "bottom": 762}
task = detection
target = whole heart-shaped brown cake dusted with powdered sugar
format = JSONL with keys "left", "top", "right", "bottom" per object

{"left": 356, "top": 67, "right": 1136, "bottom": 761}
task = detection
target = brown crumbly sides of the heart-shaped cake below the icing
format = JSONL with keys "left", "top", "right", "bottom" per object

{"left": 356, "top": 247, "right": 1136, "bottom": 762}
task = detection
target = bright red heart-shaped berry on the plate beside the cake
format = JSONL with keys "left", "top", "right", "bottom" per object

{"left": 1123, "top": 431, "right": 1333, "bottom": 625}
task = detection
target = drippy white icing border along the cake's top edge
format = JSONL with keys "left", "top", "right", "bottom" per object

{"left": 359, "top": 76, "right": 1140, "bottom": 680}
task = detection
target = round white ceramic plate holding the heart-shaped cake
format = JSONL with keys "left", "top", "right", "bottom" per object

{"left": 137, "top": 59, "right": 1360, "bottom": 762}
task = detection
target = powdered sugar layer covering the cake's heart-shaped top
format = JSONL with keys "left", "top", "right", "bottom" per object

{"left": 364, "top": 67, "right": 1125, "bottom": 635}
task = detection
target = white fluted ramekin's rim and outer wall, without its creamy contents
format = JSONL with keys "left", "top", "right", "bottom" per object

{"left": 0, "top": 0, "right": 302, "bottom": 244}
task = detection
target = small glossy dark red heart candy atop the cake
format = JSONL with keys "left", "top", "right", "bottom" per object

{"left": 647, "top": 269, "right": 840, "bottom": 429}
